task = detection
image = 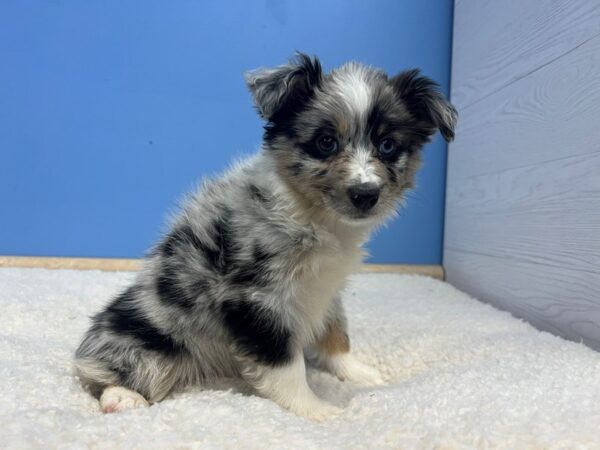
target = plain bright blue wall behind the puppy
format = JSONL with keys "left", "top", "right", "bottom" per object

{"left": 0, "top": 0, "right": 452, "bottom": 264}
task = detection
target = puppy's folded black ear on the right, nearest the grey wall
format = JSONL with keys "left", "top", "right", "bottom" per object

{"left": 390, "top": 69, "right": 458, "bottom": 142}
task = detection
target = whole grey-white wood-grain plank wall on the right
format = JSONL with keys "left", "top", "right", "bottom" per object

{"left": 444, "top": 0, "right": 600, "bottom": 350}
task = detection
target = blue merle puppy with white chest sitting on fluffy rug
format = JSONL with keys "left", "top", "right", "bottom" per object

{"left": 76, "top": 54, "right": 457, "bottom": 420}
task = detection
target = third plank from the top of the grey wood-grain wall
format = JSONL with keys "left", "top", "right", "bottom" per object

{"left": 445, "top": 151, "right": 600, "bottom": 268}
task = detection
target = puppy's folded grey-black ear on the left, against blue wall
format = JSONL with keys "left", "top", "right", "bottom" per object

{"left": 245, "top": 53, "right": 323, "bottom": 121}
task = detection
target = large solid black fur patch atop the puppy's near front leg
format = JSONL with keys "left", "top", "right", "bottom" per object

{"left": 221, "top": 300, "right": 291, "bottom": 366}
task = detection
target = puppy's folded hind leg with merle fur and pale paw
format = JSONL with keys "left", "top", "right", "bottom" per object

{"left": 75, "top": 286, "right": 195, "bottom": 412}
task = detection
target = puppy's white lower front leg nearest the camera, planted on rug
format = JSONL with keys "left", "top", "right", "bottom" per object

{"left": 245, "top": 351, "right": 342, "bottom": 421}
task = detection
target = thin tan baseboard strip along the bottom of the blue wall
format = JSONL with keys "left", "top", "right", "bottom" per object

{"left": 0, "top": 256, "right": 444, "bottom": 280}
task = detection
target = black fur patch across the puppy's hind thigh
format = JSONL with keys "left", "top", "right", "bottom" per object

{"left": 101, "top": 287, "right": 185, "bottom": 355}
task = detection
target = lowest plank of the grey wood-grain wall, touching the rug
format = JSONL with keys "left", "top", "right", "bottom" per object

{"left": 444, "top": 248, "right": 600, "bottom": 350}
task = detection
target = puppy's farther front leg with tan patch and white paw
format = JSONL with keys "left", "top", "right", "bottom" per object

{"left": 314, "top": 297, "right": 383, "bottom": 386}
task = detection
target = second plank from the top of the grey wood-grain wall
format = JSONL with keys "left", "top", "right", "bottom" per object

{"left": 448, "top": 36, "right": 600, "bottom": 179}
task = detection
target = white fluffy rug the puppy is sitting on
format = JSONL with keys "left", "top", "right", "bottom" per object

{"left": 0, "top": 269, "right": 600, "bottom": 450}
